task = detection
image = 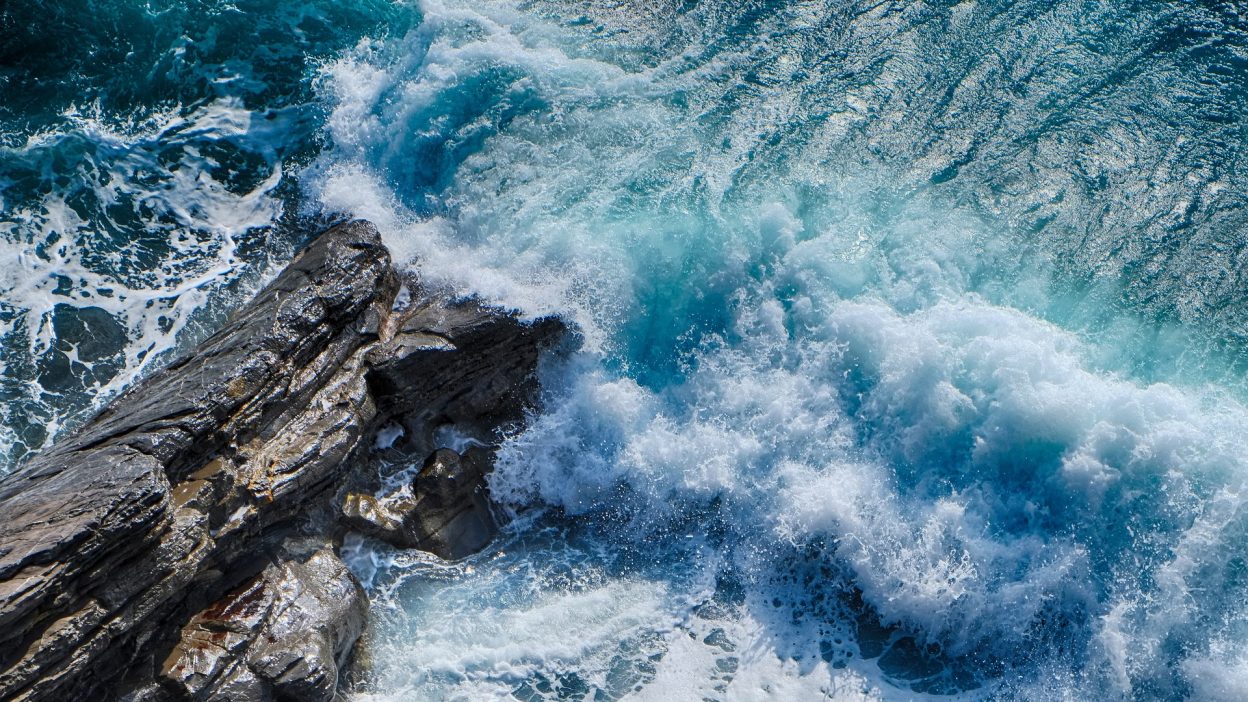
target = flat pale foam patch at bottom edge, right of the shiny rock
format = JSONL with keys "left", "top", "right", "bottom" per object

{"left": 354, "top": 542, "right": 673, "bottom": 700}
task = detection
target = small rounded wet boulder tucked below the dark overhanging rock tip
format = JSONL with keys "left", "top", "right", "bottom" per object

{"left": 342, "top": 447, "right": 495, "bottom": 558}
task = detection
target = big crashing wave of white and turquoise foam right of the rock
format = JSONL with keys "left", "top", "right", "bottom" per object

{"left": 308, "top": 1, "right": 1248, "bottom": 698}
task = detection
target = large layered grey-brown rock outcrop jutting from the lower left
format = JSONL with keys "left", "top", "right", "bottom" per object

{"left": 0, "top": 222, "right": 563, "bottom": 700}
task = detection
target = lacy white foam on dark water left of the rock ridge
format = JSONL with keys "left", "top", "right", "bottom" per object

{"left": 0, "top": 99, "right": 282, "bottom": 464}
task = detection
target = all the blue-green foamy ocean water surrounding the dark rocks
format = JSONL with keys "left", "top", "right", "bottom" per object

{"left": 0, "top": 0, "right": 1248, "bottom": 701}
